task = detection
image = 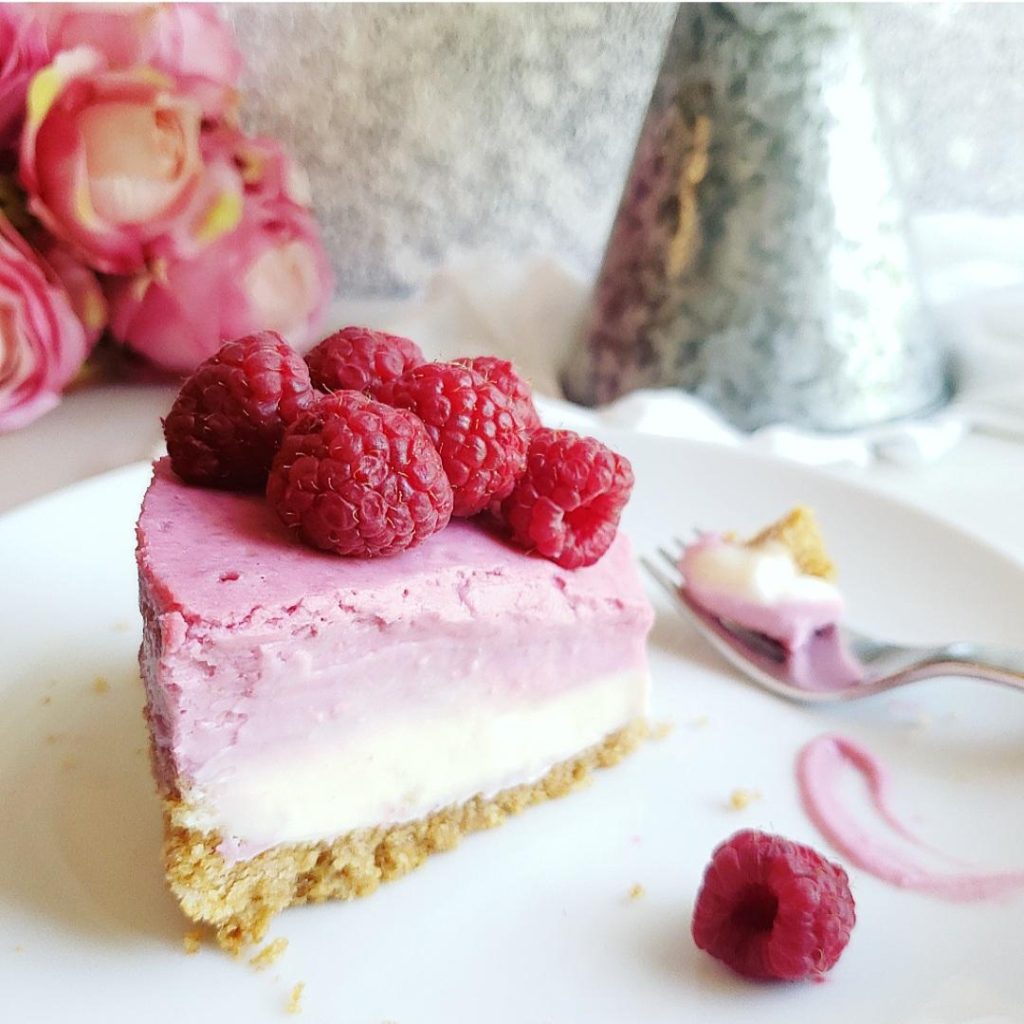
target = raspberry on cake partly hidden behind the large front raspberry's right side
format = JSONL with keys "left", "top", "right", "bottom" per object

{"left": 376, "top": 362, "right": 527, "bottom": 516}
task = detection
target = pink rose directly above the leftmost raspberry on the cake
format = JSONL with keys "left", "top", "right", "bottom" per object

{"left": 108, "top": 179, "right": 332, "bottom": 373}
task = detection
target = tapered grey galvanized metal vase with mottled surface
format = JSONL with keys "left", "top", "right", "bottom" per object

{"left": 563, "top": 4, "right": 950, "bottom": 430}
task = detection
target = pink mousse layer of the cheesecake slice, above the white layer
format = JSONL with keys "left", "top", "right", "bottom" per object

{"left": 137, "top": 459, "right": 653, "bottom": 788}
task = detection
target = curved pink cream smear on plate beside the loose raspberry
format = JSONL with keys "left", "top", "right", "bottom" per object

{"left": 797, "top": 734, "right": 1024, "bottom": 901}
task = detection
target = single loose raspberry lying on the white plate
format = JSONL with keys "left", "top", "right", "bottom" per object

{"left": 692, "top": 829, "right": 857, "bottom": 981}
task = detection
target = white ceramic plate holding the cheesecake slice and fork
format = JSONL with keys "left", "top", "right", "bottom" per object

{"left": 0, "top": 435, "right": 1024, "bottom": 1024}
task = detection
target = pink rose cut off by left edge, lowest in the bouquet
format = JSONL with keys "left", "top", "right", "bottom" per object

{"left": 0, "top": 216, "right": 89, "bottom": 431}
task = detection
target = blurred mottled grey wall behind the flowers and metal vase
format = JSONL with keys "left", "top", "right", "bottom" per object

{"left": 224, "top": 3, "right": 1024, "bottom": 296}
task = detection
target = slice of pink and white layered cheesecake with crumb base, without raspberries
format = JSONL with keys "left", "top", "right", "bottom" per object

{"left": 137, "top": 460, "right": 652, "bottom": 948}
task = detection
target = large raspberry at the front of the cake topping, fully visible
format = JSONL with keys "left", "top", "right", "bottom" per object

{"left": 266, "top": 391, "right": 452, "bottom": 558}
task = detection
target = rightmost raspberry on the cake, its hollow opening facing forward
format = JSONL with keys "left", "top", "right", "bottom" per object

{"left": 501, "top": 427, "right": 633, "bottom": 569}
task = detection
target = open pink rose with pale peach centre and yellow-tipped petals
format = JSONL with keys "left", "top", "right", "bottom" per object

{"left": 20, "top": 47, "right": 204, "bottom": 273}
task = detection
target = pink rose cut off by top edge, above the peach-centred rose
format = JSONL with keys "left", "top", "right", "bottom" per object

{"left": 31, "top": 3, "right": 242, "bottom": 99}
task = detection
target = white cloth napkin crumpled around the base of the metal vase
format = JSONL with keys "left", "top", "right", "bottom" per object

{"left": 335, "top": 215, "right": 1024, "bottom": 466}
